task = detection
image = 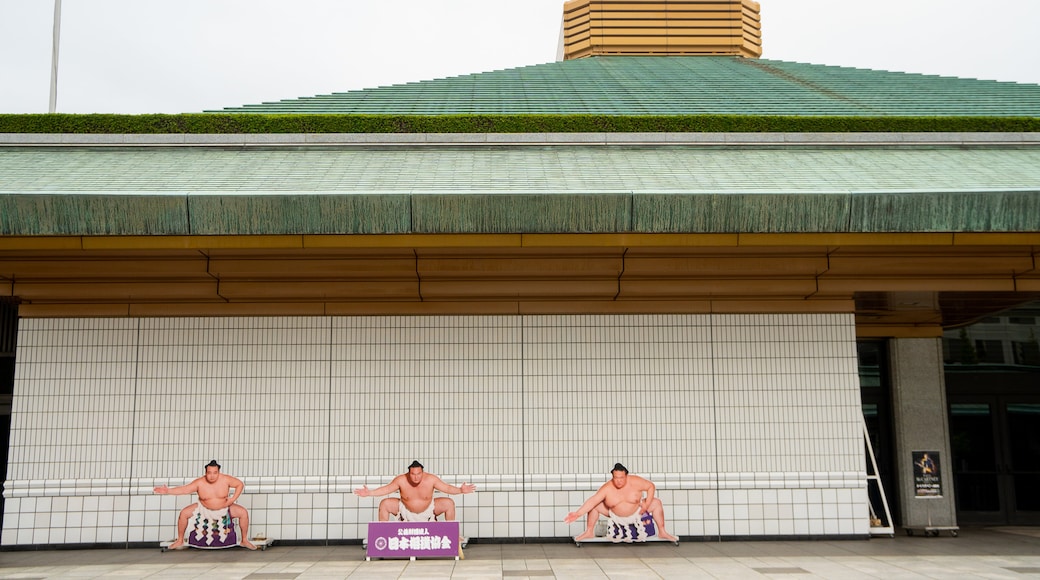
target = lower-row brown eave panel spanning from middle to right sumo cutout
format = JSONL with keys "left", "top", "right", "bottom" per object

{"left": 420, "top": 280, "right": 618, "bottom": 300}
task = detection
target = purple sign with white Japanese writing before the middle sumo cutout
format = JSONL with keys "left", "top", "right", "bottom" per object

{"left": 365, "top": 522, "right": 459, "bottom": 558}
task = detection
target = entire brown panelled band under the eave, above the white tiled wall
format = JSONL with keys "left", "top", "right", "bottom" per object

{"left": 0, "top": 234, "right": 1027, "bottom": 323}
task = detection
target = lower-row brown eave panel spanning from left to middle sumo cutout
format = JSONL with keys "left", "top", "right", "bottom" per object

{"left": 220, "top": 280, "right": 419, "bottom": 301}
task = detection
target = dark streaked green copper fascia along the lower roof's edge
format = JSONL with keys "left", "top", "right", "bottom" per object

{"left": 0, "top": 190, "right": 1040, "bottom": 236}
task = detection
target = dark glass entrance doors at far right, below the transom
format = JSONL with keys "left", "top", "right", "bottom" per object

{"left": 950, "top": 395, "right": 1040, "bottom": 525}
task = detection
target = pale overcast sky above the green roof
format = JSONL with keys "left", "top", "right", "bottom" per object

{"left": 0, "top": 0, "right": 1040, "bottom": 114}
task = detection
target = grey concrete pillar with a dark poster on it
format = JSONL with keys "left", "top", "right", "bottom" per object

{"left": 888, "top": 338, "right": 957, "bottom": 529}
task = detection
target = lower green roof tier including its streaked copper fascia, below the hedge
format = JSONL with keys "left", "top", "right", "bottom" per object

{"left": 6, "top": 146, "right": 1040, "bottom": 235}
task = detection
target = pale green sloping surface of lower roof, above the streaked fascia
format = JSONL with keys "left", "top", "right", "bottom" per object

{"left": 8, "top": 144, "right": 1040, "bottom": 194}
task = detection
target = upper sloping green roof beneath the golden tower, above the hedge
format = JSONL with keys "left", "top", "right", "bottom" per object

{"left": 211, "top": 56, "right": 1040, "bottom": 116}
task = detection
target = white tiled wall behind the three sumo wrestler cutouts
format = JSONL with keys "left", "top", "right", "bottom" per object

{"left": 2, "top": 315, "right": 868, "bottom": 545}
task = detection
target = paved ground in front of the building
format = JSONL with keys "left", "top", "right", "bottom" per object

{"left": 0, "top": 528, "right": 1040, "bottom": 580}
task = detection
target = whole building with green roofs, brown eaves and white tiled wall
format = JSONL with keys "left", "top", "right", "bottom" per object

{"left": 0, "top": 2, "right": 1040, "bottom": 547}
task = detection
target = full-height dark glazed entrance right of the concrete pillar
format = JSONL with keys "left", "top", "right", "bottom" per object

{"left": 943, "top": 302, "right": 1040, "bottom": 525}
